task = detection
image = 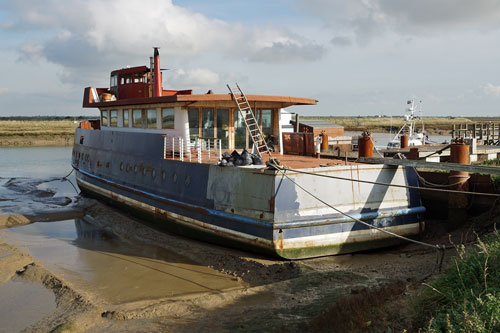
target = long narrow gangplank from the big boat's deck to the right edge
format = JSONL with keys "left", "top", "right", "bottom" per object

{"left": 358, "top": 157, "right": 500, "bottom": 175}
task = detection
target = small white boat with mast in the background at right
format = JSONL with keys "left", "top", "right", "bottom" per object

{"left": 387, "top": 99, "right": 437, "bottom": 148}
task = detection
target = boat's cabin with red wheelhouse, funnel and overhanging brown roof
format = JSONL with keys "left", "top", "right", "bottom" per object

{"left": 83, "top": 49, "right": 317, "bottom": 150}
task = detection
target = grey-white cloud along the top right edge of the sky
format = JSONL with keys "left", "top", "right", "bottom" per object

{"left": 296, "top": 0, "right": 500, "bottom": 44}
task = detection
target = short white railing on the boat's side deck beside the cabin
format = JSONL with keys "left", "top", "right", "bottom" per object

{"left": 163, "top": 136, "right": 222, "bottom": 163}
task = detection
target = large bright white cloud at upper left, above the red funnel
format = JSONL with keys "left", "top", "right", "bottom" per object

{"left": 0, "top": 0, "right": 325, "bottom": 85}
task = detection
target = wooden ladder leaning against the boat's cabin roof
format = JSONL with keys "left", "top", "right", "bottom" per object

{"left": 226, "top": 83, "right": 271, "bottom": 157}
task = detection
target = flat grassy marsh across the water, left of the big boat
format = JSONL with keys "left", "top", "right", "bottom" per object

{"left": 0, "top": 119, "right": 79, "bottom": 147}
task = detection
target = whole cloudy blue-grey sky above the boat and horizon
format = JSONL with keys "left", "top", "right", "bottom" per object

{"left": 0, "top": 0, "right": 500, "bottom": 116}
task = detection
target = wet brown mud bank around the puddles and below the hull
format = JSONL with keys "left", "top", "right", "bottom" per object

{"left": 0, "top": 181, "right": 500, "bottom": 332}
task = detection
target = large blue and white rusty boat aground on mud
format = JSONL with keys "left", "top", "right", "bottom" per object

{"left": 72, "top": 48, "right": 425, "bottom": 259}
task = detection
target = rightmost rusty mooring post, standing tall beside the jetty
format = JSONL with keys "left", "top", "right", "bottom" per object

{"left": 448, "top": 143, "right": 470, "bottom": 230}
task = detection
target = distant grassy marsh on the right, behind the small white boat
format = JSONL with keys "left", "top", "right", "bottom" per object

{"left": 301, "top": 116, "right": 500, "bottom": 135}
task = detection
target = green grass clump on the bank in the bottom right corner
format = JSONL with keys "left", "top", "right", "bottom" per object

{"left": 416, "top": 231, "right": 500, "bottom": 333}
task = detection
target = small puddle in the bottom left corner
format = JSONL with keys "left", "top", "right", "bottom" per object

{"left": 0, "top": 278, "right": 56, "bottom": 332}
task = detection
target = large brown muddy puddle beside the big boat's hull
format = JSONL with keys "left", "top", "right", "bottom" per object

{"left": 0, "top": 219, "right": 244, "bottom": 304}
